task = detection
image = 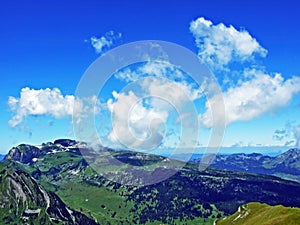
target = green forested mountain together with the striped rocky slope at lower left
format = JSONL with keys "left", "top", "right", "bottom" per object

{"left": 0, "top": 139, "right": 300, "bottom": 224}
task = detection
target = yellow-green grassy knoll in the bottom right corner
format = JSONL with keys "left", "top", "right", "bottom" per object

{"left": 216, "top": 202, "right": 300, "bottom": 225}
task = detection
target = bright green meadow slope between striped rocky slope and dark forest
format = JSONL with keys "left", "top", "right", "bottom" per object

{"left": 5, "top": 149, "right": 225, "bottom": 225}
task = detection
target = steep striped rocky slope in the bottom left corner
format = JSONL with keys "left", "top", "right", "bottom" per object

{"left": 0, "top": 167, "right": 97, "bottom": 224}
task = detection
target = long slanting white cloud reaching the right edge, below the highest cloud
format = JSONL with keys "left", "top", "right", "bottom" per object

{"left": 199, "top": 69, "right": 300, "bottom": 127}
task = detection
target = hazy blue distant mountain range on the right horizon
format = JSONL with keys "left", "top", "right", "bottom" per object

{"left": 192, "top": 148, "right": 300, "bottom": 182}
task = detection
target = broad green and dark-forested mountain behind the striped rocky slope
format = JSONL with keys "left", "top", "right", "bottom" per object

{"left": 0, "top": 140, "right": 300, "bottom": 224}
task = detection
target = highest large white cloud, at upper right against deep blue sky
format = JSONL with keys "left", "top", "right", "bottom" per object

{"left": 190, "top": 17, "right": 267, "bottom": 69}
